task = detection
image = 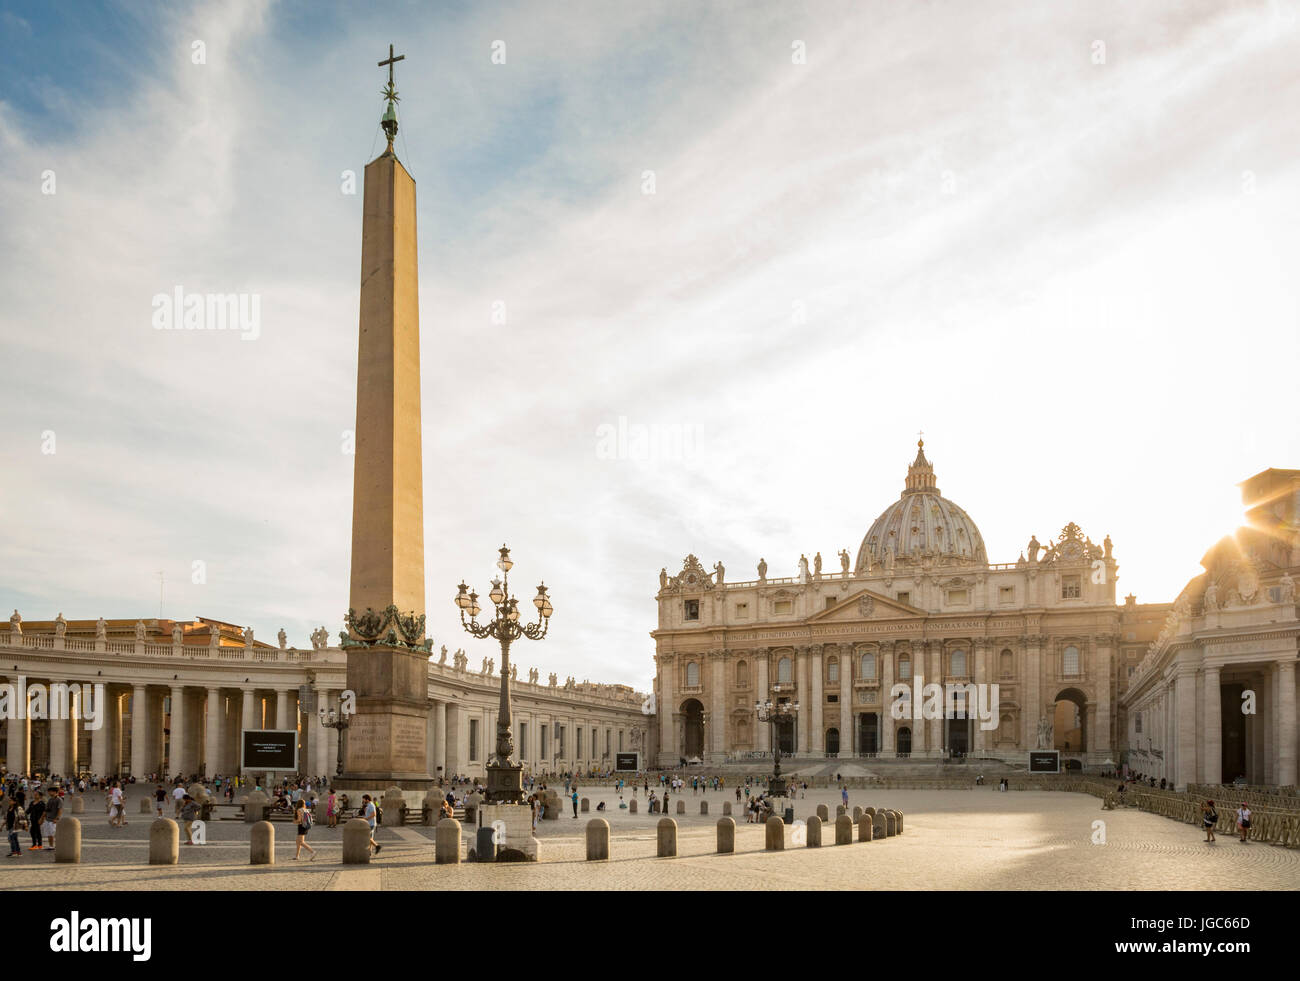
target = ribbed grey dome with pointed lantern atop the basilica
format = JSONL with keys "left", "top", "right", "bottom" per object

{"left": 857, "top": 440, "right": 988, "bottom": 574}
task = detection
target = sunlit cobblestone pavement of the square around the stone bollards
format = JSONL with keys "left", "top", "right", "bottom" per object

{"left": 0, "top": 787, "right": 1300, "bottom": 890}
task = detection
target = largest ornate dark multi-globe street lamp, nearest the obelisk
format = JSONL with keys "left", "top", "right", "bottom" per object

{"left": 455, "top": 546, "right": 554, "bottom": 804}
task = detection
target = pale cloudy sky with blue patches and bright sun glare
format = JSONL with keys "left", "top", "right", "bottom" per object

{"left": 0, "top": 0, "right": 1300, "bottom": 690}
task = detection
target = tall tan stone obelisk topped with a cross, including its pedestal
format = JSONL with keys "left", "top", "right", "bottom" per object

{"left": 342, "top": 45, "right": 432, "bottom": 790}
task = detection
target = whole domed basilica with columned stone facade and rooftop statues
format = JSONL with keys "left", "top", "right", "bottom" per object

{"left": 653, "top": 443, "right": 1169, "bottom": 765}
